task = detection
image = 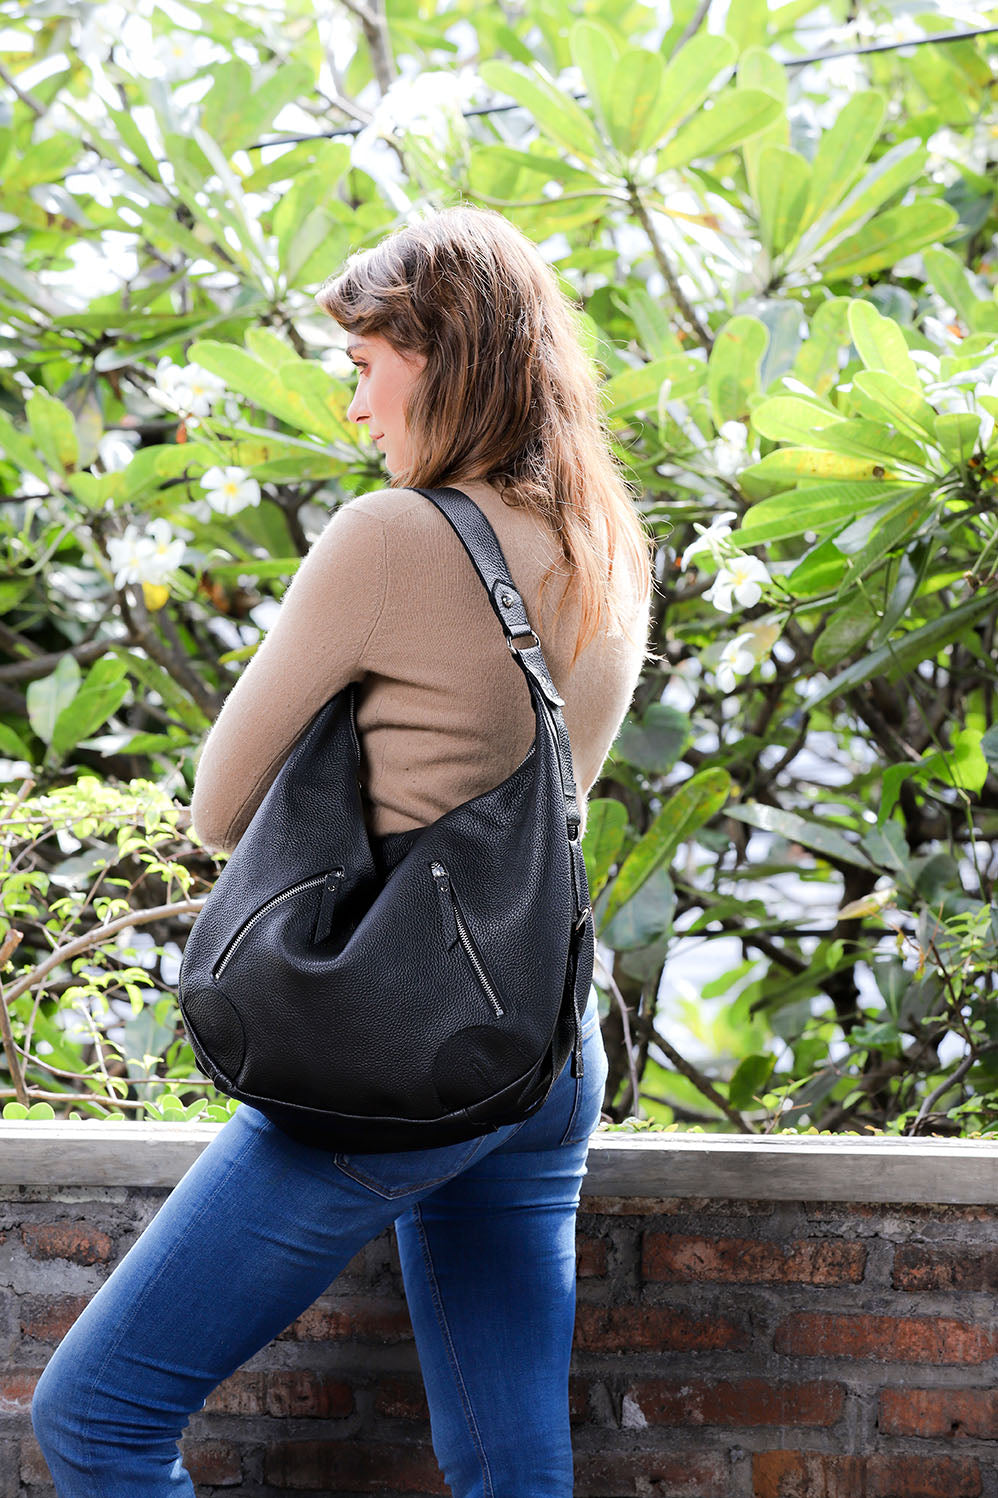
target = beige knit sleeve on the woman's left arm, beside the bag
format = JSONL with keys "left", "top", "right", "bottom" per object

{"left": 190, "top": 502, "right": 387, "bottom": 852}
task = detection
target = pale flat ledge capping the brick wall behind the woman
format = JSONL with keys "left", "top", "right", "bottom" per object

{"left": 0, "top": 1119, "right": 998, "bottom": 1206}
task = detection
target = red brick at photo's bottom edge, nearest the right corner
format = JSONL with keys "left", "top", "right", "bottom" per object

{"left": 752, "top": 1452, "right": 982, "bottom": 1498}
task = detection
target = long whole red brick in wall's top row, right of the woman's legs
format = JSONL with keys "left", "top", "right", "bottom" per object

{"left": 641, "top": 1233, "right": 866, "bottom": 1285}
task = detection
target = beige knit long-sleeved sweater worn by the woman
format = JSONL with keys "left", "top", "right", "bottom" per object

{"left": 192, "top": 479, "right": 649, "bottom": 852}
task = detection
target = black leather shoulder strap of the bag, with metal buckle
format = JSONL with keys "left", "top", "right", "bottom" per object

{"left": 417, "top": 487, "right": 581, "bottom": 842}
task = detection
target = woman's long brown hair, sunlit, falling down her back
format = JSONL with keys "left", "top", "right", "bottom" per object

{"left": 315, "top": 204, "right": 659, "bottom": 665}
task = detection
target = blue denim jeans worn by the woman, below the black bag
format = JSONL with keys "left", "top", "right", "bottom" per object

{"left": 31, "top": 987, "right": 607, "bottom": 1498}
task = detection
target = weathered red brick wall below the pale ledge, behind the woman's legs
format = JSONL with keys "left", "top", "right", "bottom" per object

{"left": 0, "top": 1138, "right": 998, "bottom": 1498}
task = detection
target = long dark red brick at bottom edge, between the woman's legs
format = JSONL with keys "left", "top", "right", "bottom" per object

{"left": 264, "top": 1441, "right": 450, "bottom": 1498}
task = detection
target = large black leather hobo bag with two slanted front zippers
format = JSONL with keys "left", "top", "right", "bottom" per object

{"left": 178, "top": 488, "right": 595, "bottom": 1153}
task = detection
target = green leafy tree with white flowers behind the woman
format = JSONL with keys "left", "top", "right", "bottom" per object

{"left": 0, "top": 0, "right": 998, "bottom": 1134}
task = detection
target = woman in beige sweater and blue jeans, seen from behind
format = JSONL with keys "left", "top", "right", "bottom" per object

{"left": 31, "top": 205, "right": 652, "bottom": 1498}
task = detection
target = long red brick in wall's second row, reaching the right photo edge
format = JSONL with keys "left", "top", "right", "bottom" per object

{"left": 773, "top": 1311, "right": 998, "bottom": 1363}
